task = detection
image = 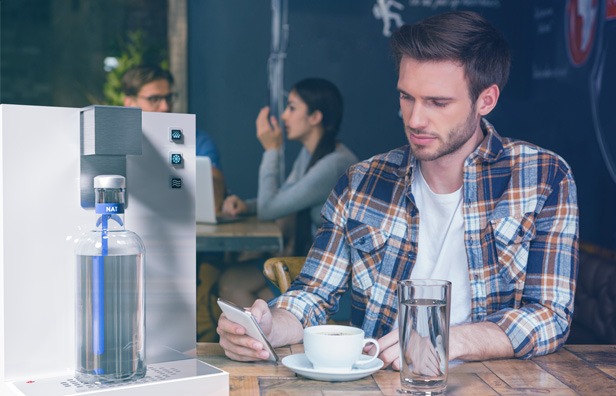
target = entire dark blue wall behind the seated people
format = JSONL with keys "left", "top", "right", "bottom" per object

{"left": 189, "top": 0, "right": 616, "bottom": 248}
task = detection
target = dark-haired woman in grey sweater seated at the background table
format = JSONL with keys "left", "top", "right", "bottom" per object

{"left": 219, "top": 78, "right": 358, "bottom": 306}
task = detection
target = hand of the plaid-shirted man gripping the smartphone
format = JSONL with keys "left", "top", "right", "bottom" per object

{"left": 216, "top": 300, "right": 272, "bottom": 362}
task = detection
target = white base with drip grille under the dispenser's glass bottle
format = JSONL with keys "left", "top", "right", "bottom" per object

{"left": 0, "top": 359, "right": 229, "bottom": 396}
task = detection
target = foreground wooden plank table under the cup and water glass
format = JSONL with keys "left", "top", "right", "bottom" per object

{"left": 197, "top": 343, "right": 616, "bottom": 396}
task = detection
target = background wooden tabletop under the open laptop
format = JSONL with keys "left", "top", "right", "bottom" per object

{"left": 197, "top": 217, "right": 282, "bottom": 252}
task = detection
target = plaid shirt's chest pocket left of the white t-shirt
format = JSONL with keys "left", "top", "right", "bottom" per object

{"left": 346, "top": 219, "right": 387, "bottom": 291}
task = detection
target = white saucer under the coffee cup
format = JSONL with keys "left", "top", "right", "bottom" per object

{"left": 282, "top": 353, "right": 383, "bottom": 381}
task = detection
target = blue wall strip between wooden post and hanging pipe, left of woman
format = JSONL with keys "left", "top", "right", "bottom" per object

{"left": 188, "top": 0, "right": 270, "bottom": 201}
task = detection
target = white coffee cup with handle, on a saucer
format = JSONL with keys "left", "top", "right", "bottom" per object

{"left": 304, "top": 325, "right": 379, "bottom": 371}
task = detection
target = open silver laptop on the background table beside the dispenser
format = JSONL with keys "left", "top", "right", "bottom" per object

{"left": 195, "top": 156, "right": 245, "bottom": 224}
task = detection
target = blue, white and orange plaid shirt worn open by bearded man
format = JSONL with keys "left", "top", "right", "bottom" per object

{"left": 271, "top": 119, "right": 578, "bottom": 358}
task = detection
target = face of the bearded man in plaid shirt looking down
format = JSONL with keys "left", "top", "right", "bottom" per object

{"left": 398, "top": 57, "right": 482, "bottom": 161}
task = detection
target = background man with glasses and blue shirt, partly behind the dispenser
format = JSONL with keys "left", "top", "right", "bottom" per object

{"left": 122, "top": 65, "right": 225, "bottom": 210}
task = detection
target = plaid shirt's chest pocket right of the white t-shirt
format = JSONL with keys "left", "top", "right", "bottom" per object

{"left": 490, "top": 213, "right": 535, "bottom": 284}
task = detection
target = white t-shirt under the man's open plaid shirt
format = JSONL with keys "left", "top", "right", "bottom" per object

{"left": 411, "top": 167, "right": 471, "bottom": 325}
